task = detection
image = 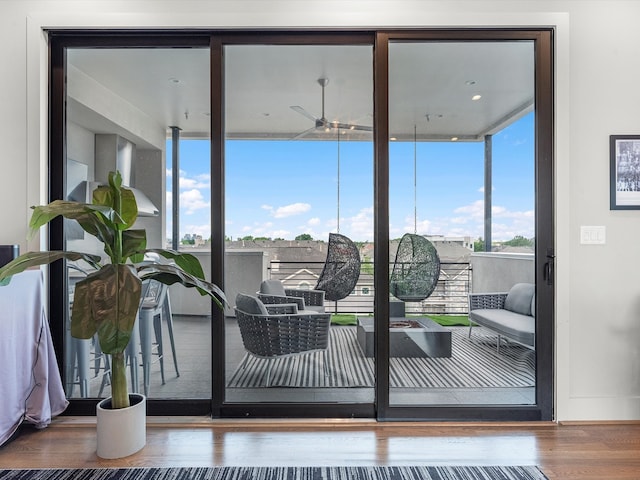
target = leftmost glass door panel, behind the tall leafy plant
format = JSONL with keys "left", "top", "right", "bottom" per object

{"left": 64, "top": 48, "right": 211, "bottom": 399}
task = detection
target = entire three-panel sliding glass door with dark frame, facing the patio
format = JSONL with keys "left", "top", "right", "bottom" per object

{"left": 50, "top": 30, "right": 553, "bottom": 420}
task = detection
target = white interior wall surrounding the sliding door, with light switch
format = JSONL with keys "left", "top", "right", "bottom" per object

{"left": 5, "top": 0, "right": 640, "bottom": 420}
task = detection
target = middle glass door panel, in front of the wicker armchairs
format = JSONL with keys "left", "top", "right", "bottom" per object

{"left": 224, "top": 45, "right": 374, "bottom": 403}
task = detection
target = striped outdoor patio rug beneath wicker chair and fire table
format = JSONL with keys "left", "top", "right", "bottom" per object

{"left": 228, "top": 326, "right": 535, "bottom": 388}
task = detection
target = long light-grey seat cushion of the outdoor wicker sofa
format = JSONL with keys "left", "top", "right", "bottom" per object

{"left": 469, "top": 308, "right": 536, "bottom": 347}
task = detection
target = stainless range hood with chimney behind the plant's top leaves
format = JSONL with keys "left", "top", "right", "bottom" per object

{"left": 68, "top": 134, "right": 160, "bottom": 217}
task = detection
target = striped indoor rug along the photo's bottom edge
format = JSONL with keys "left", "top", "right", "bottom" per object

{"left": 0, "top": 467, "right": 547, "bottom": 480}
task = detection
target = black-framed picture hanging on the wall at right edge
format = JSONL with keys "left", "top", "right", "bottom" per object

{"left": 609, "top": 135, "right": 640, "bottom": 210}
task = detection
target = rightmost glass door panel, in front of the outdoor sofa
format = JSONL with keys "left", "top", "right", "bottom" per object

{"left": 389, "top": 41, "right": 536, "bottom": 406}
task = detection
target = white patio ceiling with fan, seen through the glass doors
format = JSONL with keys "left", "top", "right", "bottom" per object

{"left": 68, "top": 42, "right": 534, "bottom": 145}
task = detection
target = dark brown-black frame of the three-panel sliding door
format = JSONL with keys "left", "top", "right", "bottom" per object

{"left": 49, "top": 28, "right": 554, "bottom": 421}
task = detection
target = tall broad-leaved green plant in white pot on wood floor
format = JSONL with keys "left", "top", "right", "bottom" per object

{"left": 0, "top": 172, "right": 225, "bottom": 458}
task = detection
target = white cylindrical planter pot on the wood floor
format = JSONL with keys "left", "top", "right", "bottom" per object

{"left": 96, "top": 393, "right": 147, "bottom": 458}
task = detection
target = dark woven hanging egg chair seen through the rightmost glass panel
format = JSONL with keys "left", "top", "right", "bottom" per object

{"left": 389, "top": 233, "right": 440, "bottom": 302}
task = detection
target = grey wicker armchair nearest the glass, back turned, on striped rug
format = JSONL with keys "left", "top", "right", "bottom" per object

{"left": 235, "top": 293, "right": 331, "bottom": 386}
